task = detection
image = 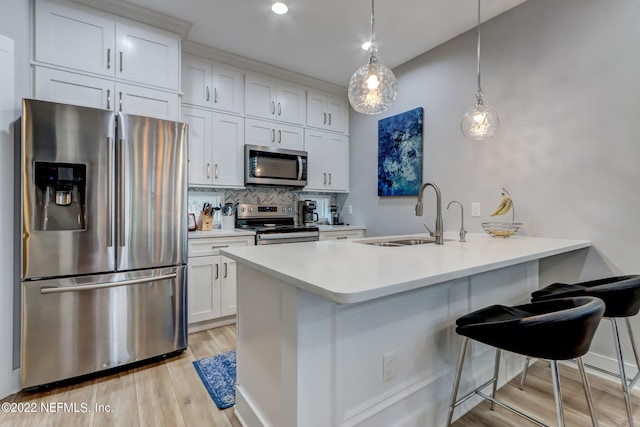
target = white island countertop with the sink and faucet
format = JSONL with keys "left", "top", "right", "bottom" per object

{"left": 221, "top": 233, "right": 591, "bottom": 304}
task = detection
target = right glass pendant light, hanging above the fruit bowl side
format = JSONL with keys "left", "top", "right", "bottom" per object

{"left": 460, "top": 0, "right": 500, "bottom": 141}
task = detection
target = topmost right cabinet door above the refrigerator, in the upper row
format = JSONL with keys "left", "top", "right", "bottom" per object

{"left": 116, "top": 22, "right": 180, "bottom": 90}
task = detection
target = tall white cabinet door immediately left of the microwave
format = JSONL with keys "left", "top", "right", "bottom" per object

{"left": 213, "top": 113, "right": 244, "bottom": 187}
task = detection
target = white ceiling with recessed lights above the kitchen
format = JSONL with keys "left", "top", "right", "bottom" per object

{"left": 122, "top": 0, "right": 525, "bottom": 87}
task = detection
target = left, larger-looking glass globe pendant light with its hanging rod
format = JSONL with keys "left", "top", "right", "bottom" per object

{"left": 348, "top": 0, "right": 398, "bottom": 114}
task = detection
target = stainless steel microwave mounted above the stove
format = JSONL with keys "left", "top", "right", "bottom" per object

{"left": 244, "top": 145, "right": 307, "bottom": 187}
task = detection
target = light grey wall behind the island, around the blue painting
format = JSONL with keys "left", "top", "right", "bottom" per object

{"left": 346, "top": 0, "right": 640, "bottom": 378}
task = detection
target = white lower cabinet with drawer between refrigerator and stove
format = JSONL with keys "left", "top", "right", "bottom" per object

{"left": 187, "top": 236, "right": 254, "bottom": 325}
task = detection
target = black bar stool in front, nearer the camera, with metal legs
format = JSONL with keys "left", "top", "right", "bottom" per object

{"left": 447, "top": 297, "right": 605, "bottom": 426}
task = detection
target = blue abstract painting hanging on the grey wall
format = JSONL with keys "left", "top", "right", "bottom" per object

{"left": 378, "top": 107, "right": 424, "bottom": 196}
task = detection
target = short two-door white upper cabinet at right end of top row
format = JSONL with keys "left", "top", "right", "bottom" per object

{"left": 307, "top": 91, "right": 349, "bottom": 133}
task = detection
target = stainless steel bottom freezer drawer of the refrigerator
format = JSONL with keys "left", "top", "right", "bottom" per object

{"left": 21, "top": 266, "right": 187, "bottom": 388}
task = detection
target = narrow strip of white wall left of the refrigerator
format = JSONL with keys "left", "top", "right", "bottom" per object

{"left": 0, "top": 0, "right": 31, "bottom": 398}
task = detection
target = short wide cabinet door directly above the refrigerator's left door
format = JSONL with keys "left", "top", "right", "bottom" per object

{"left": 34, "top": 67, "right": 115, "bottom": 110}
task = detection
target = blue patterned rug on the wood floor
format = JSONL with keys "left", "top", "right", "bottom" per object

{"left": 193, "top": 350, "right": 236, "bottom": 409}
